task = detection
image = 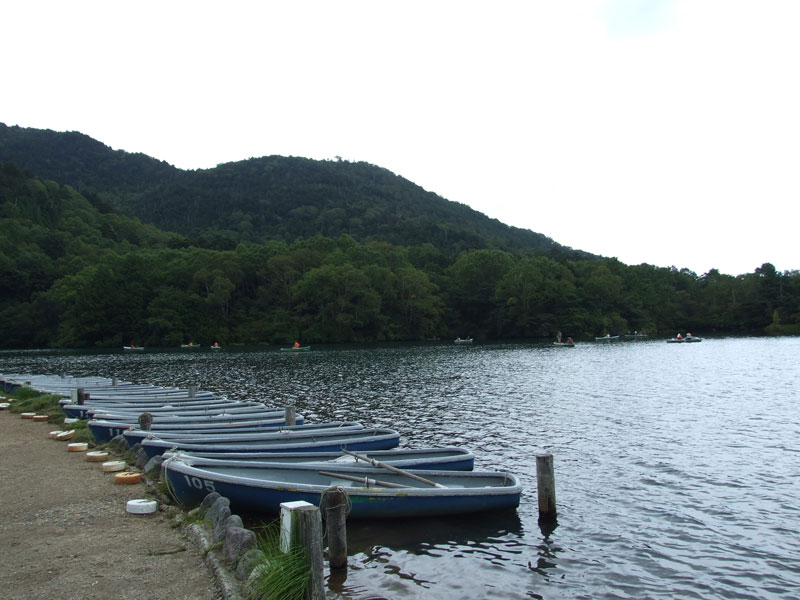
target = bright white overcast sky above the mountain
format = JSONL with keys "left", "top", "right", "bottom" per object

{"left": 0, "top": 0, "right": 800, "bottom": 275}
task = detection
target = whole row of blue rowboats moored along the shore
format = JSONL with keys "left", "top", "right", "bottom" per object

{"left": 0, "top": 374, "right": 522, "bottom": 518}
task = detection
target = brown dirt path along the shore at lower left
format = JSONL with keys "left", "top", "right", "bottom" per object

{"left": 0, "top": 410, "right": 221, "bottom": 600}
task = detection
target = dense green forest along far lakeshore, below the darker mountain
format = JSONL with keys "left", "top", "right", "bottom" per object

{"left": 0, "top": 161, "right": 800, "bottom": 348}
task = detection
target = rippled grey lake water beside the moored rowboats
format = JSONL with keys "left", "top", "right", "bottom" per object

{"left": 0, "top": 338, "right": 800, "bottom": 600}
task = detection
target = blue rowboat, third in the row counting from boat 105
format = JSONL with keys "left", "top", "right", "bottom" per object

{"left": 142, "top": 428, "right": 400, "bottom": 458}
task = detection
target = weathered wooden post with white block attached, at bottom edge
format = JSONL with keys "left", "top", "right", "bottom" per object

{"left": 280, "top": 500, "right": 325, "bottom": 600}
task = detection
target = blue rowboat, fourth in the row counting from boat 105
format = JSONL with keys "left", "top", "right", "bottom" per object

{"left": 119, "top": 419, "right": 364, "bottom": 446}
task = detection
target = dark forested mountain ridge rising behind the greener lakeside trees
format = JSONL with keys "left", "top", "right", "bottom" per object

{"left": 0, "top": 124, "right": 590, "bottom": 258}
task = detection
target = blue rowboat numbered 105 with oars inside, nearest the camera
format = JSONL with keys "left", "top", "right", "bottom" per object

{"left": 163, "top": 457, "right": 522, "bottom": 519}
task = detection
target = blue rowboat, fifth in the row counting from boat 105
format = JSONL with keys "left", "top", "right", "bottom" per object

{"left": 87, "top": 415, "right": 304, "bottom": 445}
